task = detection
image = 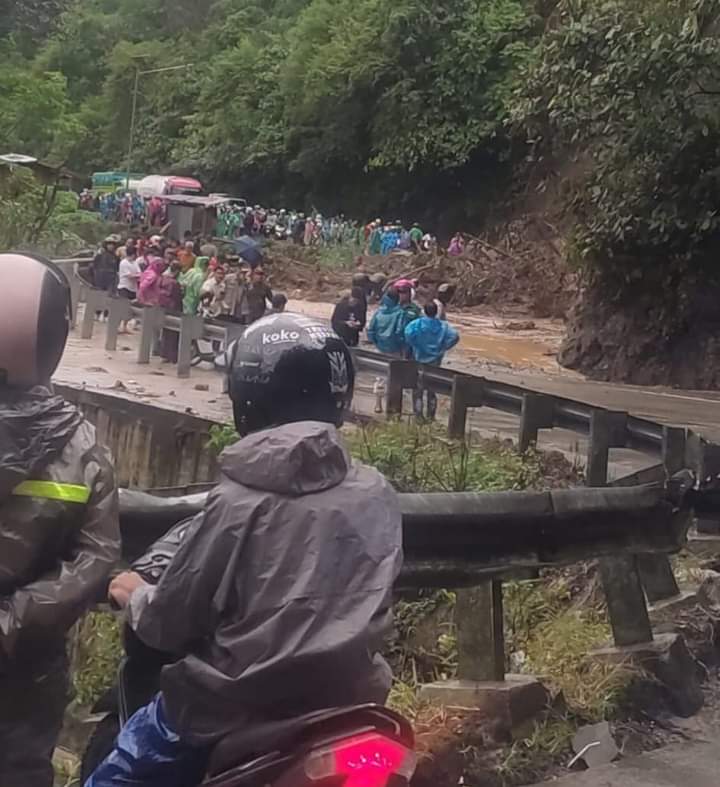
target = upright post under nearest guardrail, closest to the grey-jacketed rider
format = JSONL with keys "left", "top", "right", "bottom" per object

{"left": 455, "top": 580, "right": 505, "bottom": 681}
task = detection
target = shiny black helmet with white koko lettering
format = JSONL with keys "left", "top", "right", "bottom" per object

{"left": 226, "top": 312, "right": 355, "bottom": 436}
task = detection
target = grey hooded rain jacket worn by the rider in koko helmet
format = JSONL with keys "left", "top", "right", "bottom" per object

{"left": 129, "top": 421, "right": 402, "bottom": 744}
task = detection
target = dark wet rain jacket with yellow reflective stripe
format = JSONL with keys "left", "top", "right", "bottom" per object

{"left": 0, "top": 388, "right": 120, "bottom": 660}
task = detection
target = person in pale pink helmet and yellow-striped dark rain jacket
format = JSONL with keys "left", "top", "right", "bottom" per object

{"left": 0, "top": 254, "right": 119, "bottom": 787}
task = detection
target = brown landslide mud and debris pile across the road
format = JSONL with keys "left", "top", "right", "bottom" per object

{"left": 267, "top": 216, "right": 577, "bottom": 317}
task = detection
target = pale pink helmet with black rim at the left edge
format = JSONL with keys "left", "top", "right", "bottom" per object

{"left": 0, "top": 253, "right": 70, "bottom": 388}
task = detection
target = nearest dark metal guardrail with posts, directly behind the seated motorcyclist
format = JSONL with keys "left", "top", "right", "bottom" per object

{"left": 120, "top": 483, "right": 696, "bottom": 700}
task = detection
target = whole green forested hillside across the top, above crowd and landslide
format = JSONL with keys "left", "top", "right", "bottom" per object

{"left": 0, "top": 0, "right": 720, "bottom": 384}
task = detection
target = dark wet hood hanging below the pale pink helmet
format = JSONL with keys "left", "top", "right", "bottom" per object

{"left": 0, "top": 386, "right": 83, "bottom": 502}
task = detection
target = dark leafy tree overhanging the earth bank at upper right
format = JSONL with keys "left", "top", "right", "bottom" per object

{"left": 514, "top": 0, "right": 720, "bottom": 290}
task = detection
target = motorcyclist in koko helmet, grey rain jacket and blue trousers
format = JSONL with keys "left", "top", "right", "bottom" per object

{"left": 86, "top": 313, "right": 402, "bottom": 787}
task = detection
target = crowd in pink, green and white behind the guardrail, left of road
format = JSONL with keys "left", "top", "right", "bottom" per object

{"left": 89, "top": 235, "right": 287, "bottom": 361}
